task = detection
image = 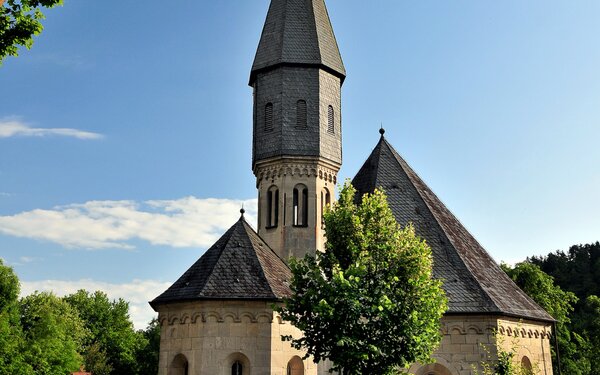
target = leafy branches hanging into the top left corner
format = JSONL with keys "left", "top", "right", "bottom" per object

{"left": 0, "top": 0, "right": 62, "bottom": 65}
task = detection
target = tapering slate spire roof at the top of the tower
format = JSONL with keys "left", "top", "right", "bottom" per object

{"left": 250, "top": 0, "right": 346, "bottom": 85}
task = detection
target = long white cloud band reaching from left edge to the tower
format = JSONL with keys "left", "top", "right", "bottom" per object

{"left": 0, "top": 197, "right": 257, "bottom": 249}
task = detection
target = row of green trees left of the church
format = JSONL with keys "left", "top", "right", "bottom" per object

{"left": 0, "top": 259, "right": 160, "bottom": 375}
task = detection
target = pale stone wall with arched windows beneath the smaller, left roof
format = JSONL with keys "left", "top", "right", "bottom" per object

{"left": 158, "top": 301, "right": 317, "bottom": 375}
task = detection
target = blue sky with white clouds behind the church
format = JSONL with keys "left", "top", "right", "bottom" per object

{"left": 0, "top": 0, "right": 600, "bottom": 327}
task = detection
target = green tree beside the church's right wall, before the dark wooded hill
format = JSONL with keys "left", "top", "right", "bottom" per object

{"left": 502, "top": 262, "right": 590, "bottom": 375}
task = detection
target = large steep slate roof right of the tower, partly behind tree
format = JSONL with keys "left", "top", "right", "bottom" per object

{"left": 352, "top": 132, "right": 553, "bottom": 321}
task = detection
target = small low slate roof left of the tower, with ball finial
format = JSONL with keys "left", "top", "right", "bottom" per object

{"left": 150, "top": 216, "right": 291, "bottom": 308}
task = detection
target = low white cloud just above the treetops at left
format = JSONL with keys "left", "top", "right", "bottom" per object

{"left": 21, "top": 279, "right": 172, "bottom": 329}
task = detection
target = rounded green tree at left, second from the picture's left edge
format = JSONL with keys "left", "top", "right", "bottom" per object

{"left": 20, "top": 292, "right": 86, "bottom": 375}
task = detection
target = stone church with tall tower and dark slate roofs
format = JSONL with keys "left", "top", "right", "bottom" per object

{"left": 150, "top": 0, "right": 554, "bottom": 375}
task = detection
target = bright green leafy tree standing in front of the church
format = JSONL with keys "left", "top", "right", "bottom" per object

{"left": 277, "top": 182, "right": 447, "bottom": 374}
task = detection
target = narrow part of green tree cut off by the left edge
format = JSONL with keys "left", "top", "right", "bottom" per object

{"left": 0, "top": 259, "right": 32, "bottom": 375}
